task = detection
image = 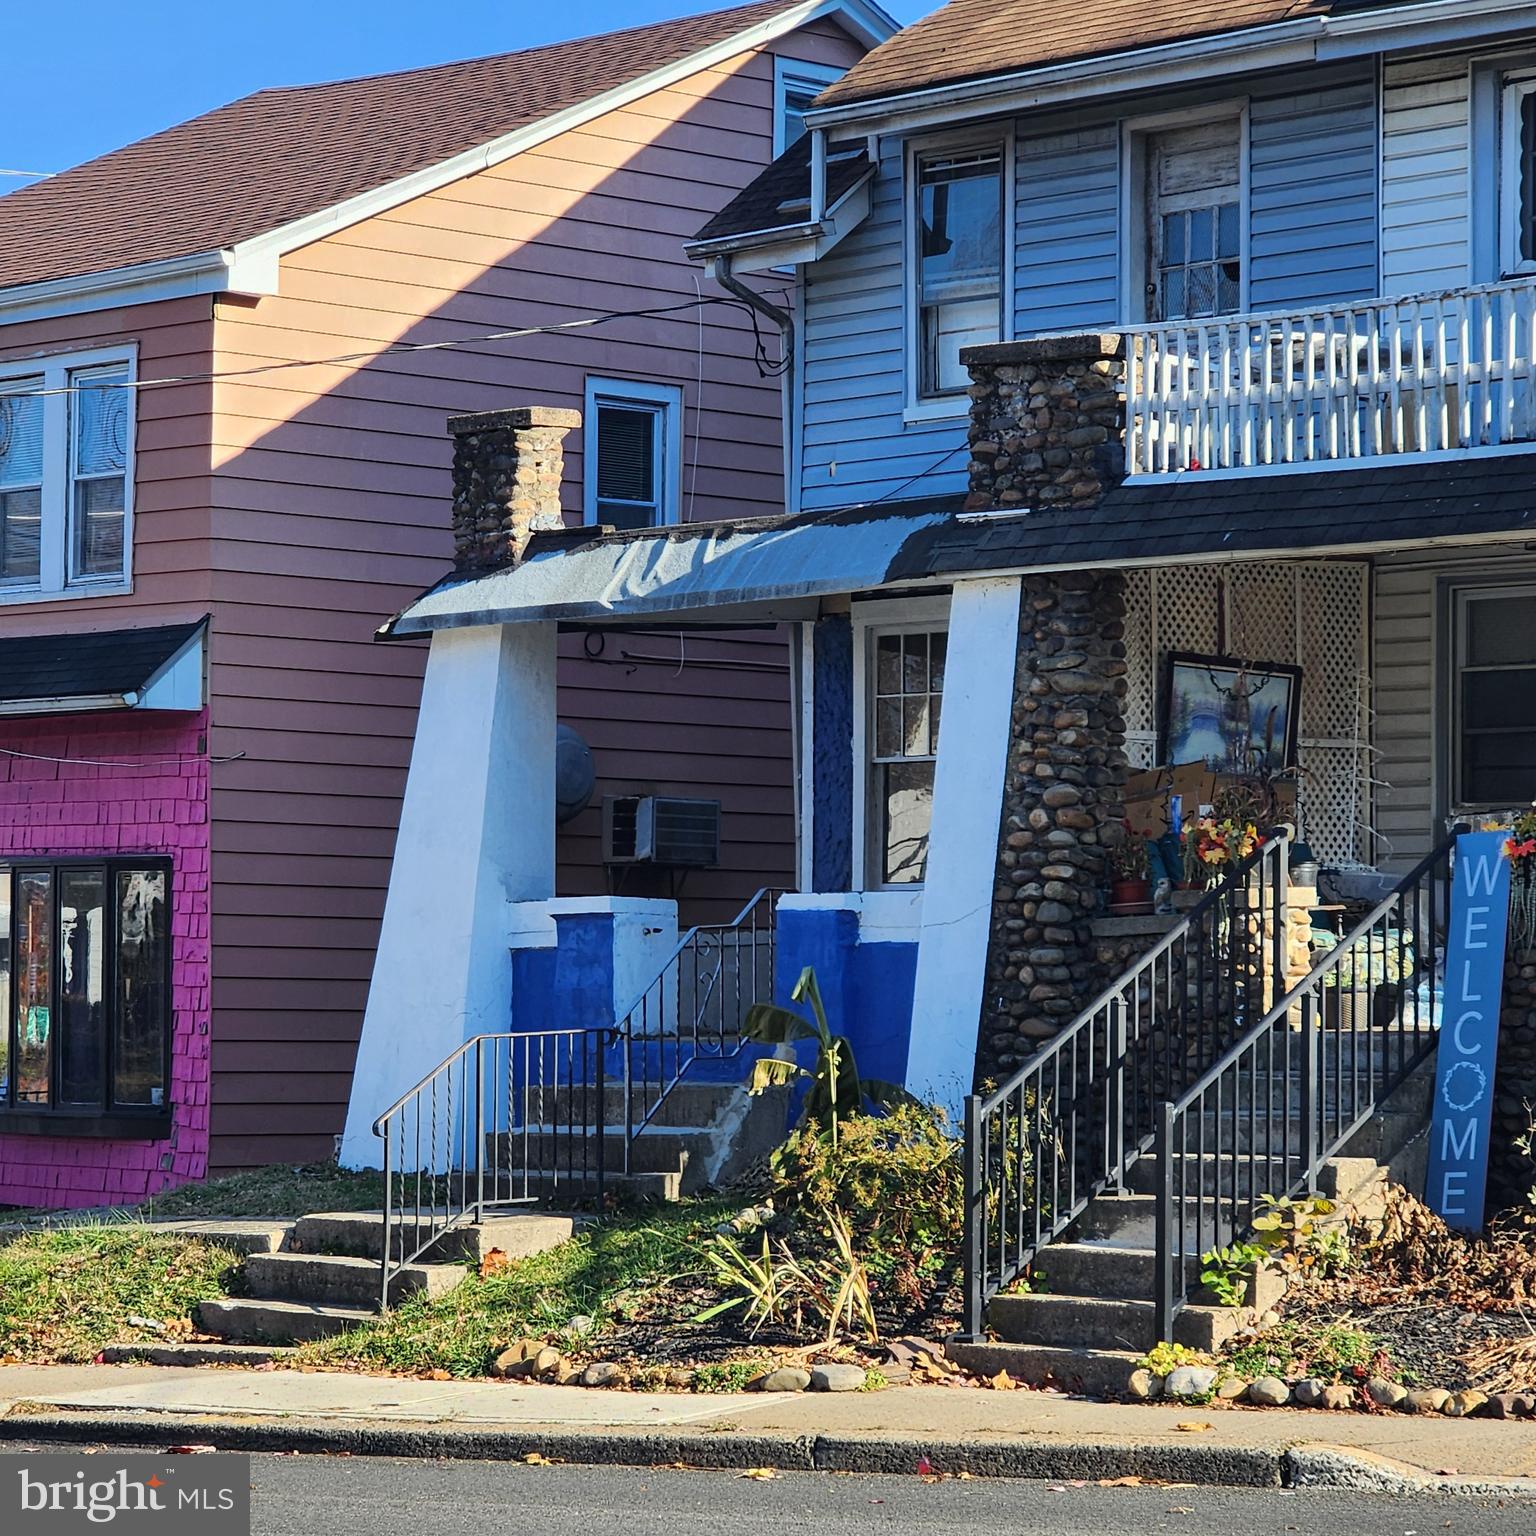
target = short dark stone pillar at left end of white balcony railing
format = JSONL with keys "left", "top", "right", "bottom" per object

{"left": 960, "top": 335, "right": 1126, "bottom": 511}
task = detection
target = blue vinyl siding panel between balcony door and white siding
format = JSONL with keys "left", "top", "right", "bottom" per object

{"left": 1249, "top": 72, "right": 1378, "bottom": 310}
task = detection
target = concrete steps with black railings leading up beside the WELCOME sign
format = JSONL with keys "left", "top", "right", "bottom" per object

{"left": 946, "top": 1064, "right": 1433, "bottom": 1396}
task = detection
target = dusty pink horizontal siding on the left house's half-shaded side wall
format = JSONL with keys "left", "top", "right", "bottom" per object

{"left": 199, "top": 23, "right": 859, "bottom": 1167}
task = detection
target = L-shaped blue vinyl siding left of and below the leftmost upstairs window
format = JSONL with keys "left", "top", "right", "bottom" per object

{"left": 800, "top": 138, "right": 969, "bottom": 510}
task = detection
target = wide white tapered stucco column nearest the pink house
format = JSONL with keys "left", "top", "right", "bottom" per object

{"left": 341, "top": 624, "right": 554, "bottom": 1167}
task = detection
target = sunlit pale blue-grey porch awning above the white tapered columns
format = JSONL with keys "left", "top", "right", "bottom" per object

{"left": 379, "top": 498, "right": 954, "bottom": 639}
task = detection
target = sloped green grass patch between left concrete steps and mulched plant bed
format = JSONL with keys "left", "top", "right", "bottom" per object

{"left": 300, "top": 1201, "right": 733, "bottom": 1376}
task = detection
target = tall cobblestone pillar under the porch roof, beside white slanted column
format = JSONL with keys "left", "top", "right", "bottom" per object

{"left": 977, "top": 571, "right": 1126, "bottom": 1084}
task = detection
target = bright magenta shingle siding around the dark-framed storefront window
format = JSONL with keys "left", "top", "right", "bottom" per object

{"left": 0, "top": 714, "right": 209, "bottom": 1206}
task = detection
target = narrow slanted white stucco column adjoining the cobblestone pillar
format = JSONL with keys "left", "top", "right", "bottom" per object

{"left": 906, "top": 579, "right": 1020, "bottom": 1129}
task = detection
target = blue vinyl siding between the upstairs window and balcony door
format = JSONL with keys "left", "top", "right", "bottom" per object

{"left": 1014, "top": 123, "right": 1120, "bottom": 336}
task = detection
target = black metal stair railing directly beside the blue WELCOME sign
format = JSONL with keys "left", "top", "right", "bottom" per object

{"left": 1155, "top": 828, "right": 1464, "bottom": 1339}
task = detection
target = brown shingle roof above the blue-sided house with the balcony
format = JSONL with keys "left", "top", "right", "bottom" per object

{"left": 817, "top": 0, "right": 1395, "bottom": 106}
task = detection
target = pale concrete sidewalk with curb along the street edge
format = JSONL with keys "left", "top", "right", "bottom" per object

{"left": 0, "top": 1366, "right": 1536, "bottom": 1496}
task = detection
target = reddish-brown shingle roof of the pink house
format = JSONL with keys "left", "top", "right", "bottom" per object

{"left": 0, "top": 0, "right": 791, "bottom": 289}
